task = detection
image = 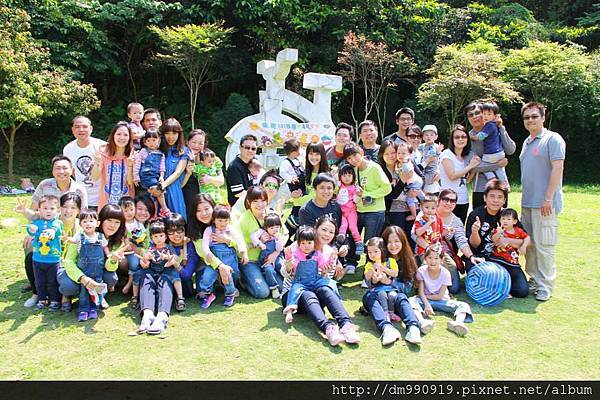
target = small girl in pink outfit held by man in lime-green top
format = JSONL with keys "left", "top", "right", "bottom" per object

{"left": 336, "top": 164, "right": 365, "bottom": 256}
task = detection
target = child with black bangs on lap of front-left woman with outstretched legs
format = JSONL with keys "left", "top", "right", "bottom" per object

{"left": 133, "top": 221, "right": 185, "bottom": 310}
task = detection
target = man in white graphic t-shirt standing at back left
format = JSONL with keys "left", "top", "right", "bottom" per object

{"left": 63, "top": 115, "right": 106, "bottom": 209}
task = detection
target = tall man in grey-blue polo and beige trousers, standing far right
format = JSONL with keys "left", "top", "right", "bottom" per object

{"left": 519, "top": 102, "right": 566, "bottom": 301}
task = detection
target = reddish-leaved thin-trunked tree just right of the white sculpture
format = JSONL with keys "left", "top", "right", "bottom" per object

{"left": 338, "top": 32, "right": 414, "bottom": 135}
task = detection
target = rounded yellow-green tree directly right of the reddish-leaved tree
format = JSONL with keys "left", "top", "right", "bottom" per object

{"left": 417, "top": 41, "right": 521, "bottom": 127}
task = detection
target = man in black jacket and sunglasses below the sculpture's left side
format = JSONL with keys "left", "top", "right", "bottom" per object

{"left": 227, "top": 135, "right": 258, "bottom": 206}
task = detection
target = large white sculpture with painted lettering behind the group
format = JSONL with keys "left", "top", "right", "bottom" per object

{"left": 225, "top": 49, "right": 342, "bottom": 169}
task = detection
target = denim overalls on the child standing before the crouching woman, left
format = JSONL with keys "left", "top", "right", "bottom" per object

{"left": 77, "top": 232, "right": 105, "bottom": 311}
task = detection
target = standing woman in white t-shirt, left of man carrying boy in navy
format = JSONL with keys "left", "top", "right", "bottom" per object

{"left": 440, "top": 125, "right": 481, "bottom": 223}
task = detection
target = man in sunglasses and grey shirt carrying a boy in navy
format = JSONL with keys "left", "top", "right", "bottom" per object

{"left": 465, "top": 101, "right": 517, "bottom": 209}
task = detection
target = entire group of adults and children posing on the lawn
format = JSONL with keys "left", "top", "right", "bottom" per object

{"left": 17, "top": 100, "right": 565, "bottom": 346}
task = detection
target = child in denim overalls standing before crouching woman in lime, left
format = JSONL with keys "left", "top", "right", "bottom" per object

{"left": 70, "top": 210, "right": 109, "bottom": 322}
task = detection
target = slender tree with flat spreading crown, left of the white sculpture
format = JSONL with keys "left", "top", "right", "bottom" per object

{"left": 150, "top": 23, "right": 233, "bottom": 129}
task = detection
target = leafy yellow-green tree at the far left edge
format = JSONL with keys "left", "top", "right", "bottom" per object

{"left": 0, "top": 5, "right": 99, "bottom": 182}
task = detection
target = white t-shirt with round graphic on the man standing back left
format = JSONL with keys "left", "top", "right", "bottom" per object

{"left": 63, "top": 137, "right": 106, "bottom": 207}
